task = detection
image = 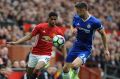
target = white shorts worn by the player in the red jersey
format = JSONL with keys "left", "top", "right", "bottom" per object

{"left": 28, "top": 54, "right": 51, "bottom": 68}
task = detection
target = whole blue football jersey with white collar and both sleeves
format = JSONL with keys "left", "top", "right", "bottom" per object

{"left": 73, "top": 14, "right": 103, "bottom": 50}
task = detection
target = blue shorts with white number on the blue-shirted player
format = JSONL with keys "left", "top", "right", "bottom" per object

{"left": 66, "top": 41, "right": 92, "bottom": 64}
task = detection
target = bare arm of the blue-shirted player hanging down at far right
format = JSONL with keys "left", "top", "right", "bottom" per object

{"left": 98, "top": 29, "right": 109, "bottom": 56}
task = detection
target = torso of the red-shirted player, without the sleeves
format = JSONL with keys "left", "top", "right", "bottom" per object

{"left": 33, "top": 24, "right": 59, "bottom": 55}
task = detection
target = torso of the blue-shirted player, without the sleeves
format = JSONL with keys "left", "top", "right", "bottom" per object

{"left": 75, "top": 16, "right": 95, "bottom": 47}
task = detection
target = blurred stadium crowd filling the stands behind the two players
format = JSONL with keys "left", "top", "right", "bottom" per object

{"left": 0, "top": 0, "right": 120, "bottom": 79}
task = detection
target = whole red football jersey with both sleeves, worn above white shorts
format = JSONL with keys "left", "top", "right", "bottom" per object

{"left": 32, "top": 23, "right": 63, "bottom": 56}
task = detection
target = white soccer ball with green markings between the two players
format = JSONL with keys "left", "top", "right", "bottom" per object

{"left": 53, "top": 35, "right": 65, "bottom": 47}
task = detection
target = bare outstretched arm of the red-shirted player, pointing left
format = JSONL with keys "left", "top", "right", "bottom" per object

{"left": 7, "top": 33, "right": 32, "bottom": 45}
